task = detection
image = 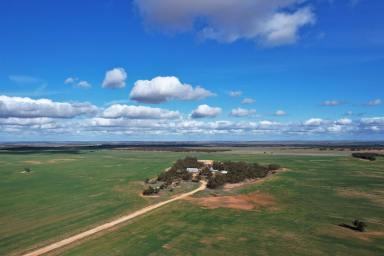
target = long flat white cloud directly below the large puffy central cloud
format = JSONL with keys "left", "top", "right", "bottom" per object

{"left": 102, "top": 104, "right": 180, "bottom": 119}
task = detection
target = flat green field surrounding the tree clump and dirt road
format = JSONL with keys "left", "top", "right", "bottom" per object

{"left": 0, "top": 150, "right": 384, "bottom": 255}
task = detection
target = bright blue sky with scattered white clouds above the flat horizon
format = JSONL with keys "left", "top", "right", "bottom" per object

{"left": 0, "top": 0, "right": 384, "bottom": 141}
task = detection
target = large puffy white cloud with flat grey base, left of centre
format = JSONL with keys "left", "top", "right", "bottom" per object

{"left": 130, "top": 76, "right": 215, "bottom": 104}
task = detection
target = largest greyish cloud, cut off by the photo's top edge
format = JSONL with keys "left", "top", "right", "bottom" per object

{"left": 136, "top": 0, "right": 316, "bottom": 46}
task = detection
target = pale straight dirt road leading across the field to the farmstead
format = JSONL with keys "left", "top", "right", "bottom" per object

{"left": 23, "top": 181, "right": 207, "bottom": 256}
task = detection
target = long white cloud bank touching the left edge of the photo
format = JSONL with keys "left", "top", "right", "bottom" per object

{"left": 0, "top": 95, "right": 97, "bottom": 118}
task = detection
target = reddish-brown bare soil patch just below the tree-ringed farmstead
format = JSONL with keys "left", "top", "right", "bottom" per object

{"left": 186, "top": 192, "right": 277, "bottom": 211}
